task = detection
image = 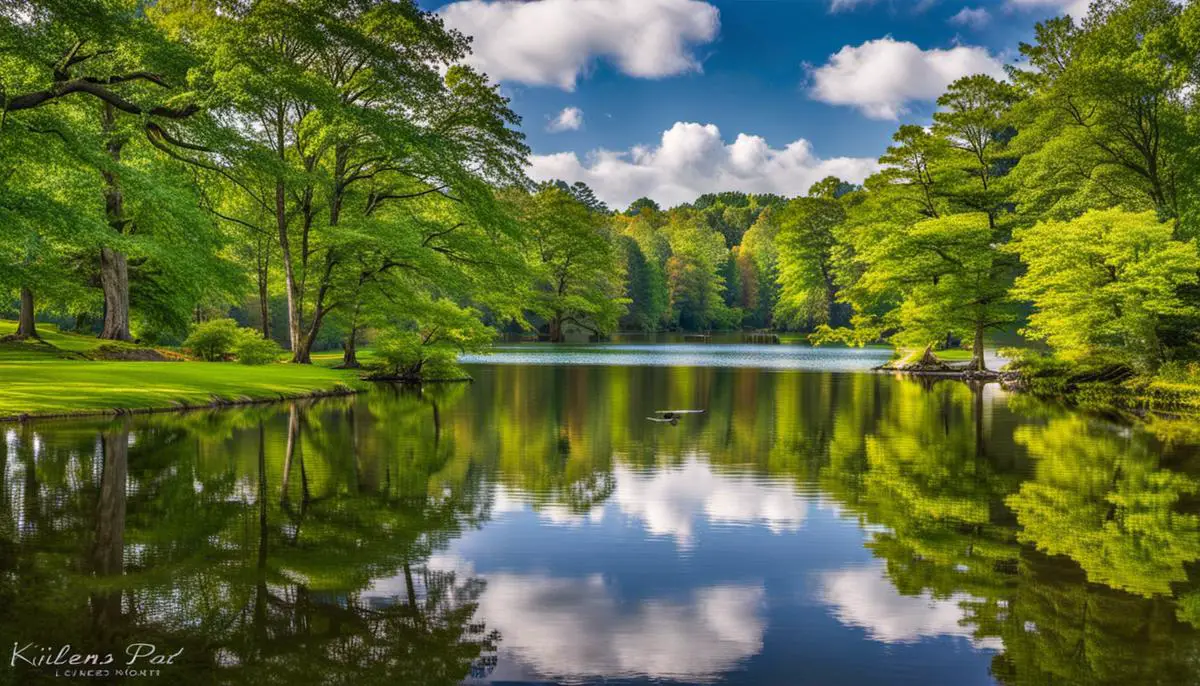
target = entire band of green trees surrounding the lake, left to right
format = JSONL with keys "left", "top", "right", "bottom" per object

{"left": 0, "top": 0, "right": 1200, "bottom": 377}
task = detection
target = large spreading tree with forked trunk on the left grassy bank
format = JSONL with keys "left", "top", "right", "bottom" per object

{"left": 168, "top": 0, "right": 528, "bottom": 363}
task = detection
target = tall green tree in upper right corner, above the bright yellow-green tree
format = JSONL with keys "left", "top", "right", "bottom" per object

{"left": 1013, "top": 0, "right": 1194, "bottom": 229}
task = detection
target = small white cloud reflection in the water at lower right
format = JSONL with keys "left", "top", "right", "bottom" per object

{"left": 820, "top": 564, "right": 1003, "bottom": 650}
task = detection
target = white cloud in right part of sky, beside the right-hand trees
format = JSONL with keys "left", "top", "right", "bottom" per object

{"left": 809, "top": 36, "right": 1004, "bottom": 119}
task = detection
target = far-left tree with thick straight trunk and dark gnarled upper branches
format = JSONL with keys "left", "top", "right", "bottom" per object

{"left": 2, "top": 0, "right": 218, "bottom": 339}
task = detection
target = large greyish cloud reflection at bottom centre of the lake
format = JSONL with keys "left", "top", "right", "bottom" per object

{"left": 431, "top": 556, "right": 766, "bottom": 681}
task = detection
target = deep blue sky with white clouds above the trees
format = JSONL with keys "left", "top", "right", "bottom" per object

{"left": 422, "top": 0, "right": 1087, "bottom": 209}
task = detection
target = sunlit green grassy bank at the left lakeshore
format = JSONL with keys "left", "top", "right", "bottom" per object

{"left": 0, "top": 321, "right": 365, "bottom": 419}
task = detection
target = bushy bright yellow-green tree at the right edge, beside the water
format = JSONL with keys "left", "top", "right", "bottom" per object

{"left": 1012, "top": 210, "right": 1200, "bottom": 366}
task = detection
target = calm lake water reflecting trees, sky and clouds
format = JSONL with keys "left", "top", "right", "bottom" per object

{"left": 0, "top": 347, "right": 1200, "bottom": 686}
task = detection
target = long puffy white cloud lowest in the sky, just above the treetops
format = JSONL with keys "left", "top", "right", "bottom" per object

{"left": 529, "top": 121, "right": 878, "bottom": 207}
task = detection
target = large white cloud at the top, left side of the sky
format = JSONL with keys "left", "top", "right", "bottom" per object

{"left": 438, "top": 0, "right": 720, "bottom": 90}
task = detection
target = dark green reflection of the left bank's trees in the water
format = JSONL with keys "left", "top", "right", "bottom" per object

{"left": 0, "top": 393, "right": 499, "bottom": 684}
